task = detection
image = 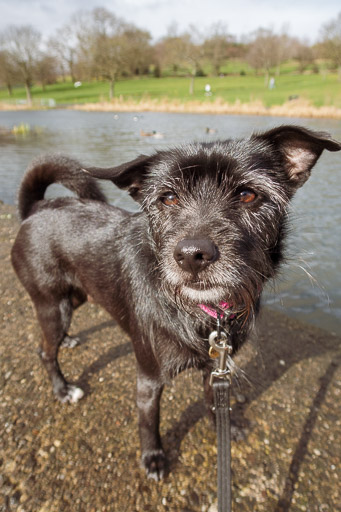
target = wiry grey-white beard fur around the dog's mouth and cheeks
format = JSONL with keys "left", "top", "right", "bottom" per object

{"left": 158, "top": 230, "right": 275, "bottom": 318}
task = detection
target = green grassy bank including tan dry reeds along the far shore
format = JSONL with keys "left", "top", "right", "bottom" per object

{"left": 0, "top": 74, "right": 341, "bottom": 117}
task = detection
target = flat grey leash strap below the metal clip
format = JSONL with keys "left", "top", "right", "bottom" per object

{"left": 213, "top": 379, "right": 232, "bottom": 512}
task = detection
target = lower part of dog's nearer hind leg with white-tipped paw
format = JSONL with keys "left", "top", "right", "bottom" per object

{"left": 35, "top": 298, "right": 84, "bottom": 403}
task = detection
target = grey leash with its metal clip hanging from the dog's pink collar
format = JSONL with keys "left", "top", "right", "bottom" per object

{"left": 208, "top": 314, "right": 232, "bottom": 512}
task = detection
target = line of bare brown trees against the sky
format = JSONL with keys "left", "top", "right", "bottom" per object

{"left": 0, "top": 7, "right": 341, "bottom": 104}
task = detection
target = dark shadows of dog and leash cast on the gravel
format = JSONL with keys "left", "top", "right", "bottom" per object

{"left": 71, "top": 313, "right": 340, "bottom": 512}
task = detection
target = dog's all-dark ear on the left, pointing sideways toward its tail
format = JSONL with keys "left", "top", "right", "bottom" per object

{"left": 82, "top": 155, "right": 153, "bottom": 201}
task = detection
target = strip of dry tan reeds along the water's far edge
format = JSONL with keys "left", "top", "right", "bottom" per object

{"left": 0, "top": 98, "right": 341, "bottom": 119}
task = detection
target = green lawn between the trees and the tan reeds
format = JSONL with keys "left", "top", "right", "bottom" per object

{"left": 0, "top": 70, "right": 341, "bottom": 108}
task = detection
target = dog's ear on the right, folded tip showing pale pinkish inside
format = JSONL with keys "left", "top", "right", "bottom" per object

{"left": 256, "top": 125, "right": 341, "bottom": 188}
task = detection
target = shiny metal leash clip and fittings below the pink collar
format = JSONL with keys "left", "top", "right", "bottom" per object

{"left": 208, "top": 319, "right": 232, "bottom": 386}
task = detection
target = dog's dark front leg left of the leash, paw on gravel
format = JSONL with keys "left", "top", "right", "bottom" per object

{"left": 137, "top": 368, "right": 167, "bottom": 481}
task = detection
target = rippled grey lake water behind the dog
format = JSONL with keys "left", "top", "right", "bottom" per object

{"left": 0, "top": 110, "right": 341, "bottom": 334}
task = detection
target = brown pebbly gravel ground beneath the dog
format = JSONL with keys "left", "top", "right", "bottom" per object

{"left": 0, "top": 205, "right": 341, "bottom": 512}
